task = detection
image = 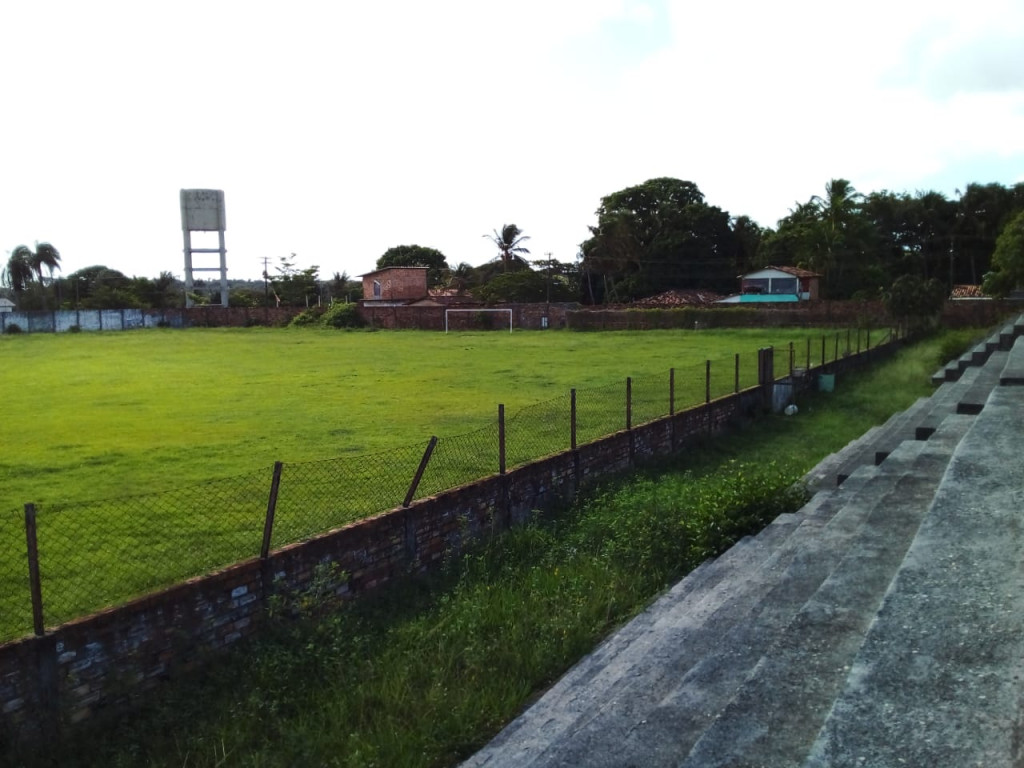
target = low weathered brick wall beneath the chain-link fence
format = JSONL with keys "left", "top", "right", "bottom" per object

{"left": 0, "top": 343, "right": 899, "bottom": 746}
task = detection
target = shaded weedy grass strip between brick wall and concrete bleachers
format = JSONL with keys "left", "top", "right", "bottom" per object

{"left": 14, "top": 335, "right": 970, "bottom": 768}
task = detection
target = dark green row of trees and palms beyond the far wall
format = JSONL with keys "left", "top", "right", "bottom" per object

{"left": 8, "top": 177, "right": 1024, "bottom": 309}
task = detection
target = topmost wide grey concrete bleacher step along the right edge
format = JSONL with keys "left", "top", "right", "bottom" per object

{"left": 805, "top": 387, "right": 1024, "bottom": 768}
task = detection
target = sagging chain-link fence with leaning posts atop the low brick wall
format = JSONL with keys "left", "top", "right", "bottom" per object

{"left": 0, "top": 332, "right": 890, "bottom": 642}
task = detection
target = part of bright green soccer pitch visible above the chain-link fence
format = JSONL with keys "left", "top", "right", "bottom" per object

{"left": 0, "top": 329, "right": 846, "bottom": 509}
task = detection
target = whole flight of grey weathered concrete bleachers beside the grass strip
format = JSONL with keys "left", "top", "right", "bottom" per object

{"left": 464, "top": 322, "right": 1024, "bottom": 768}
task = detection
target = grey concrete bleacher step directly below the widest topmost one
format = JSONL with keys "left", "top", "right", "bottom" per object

{"left": 677, "top": 418, "right": 970, "bottom": 767}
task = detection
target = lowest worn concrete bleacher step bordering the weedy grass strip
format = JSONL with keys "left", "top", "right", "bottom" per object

{"left": 466, "top": 434, "right": 954, "bottom": 766}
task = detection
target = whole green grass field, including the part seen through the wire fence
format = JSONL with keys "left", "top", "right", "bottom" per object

{"left": 0, "top": 329, "right": 882, "bottom": 640}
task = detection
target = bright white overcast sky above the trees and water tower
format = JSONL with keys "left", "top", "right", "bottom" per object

{"left": 0, "top": 0, "right": 1024, "bottom": 279}
